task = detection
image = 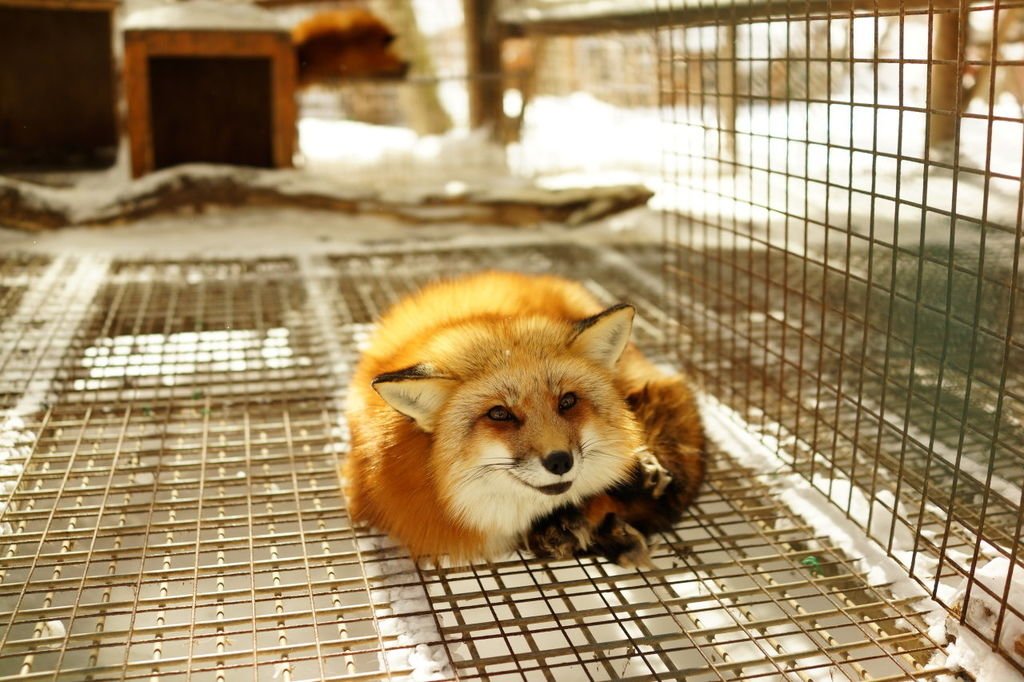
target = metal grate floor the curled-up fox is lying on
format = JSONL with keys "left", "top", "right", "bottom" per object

{"left": 0, "top": 244, "right": 940, "bottom": 682}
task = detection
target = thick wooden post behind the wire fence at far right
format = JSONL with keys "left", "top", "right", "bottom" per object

{"left": 928, "top": 8, "right": 967, "bottom": 148}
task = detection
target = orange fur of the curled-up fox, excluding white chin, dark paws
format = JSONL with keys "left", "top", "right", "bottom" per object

{"left": 343, "top": 272, "right": 702, "bottom": 562}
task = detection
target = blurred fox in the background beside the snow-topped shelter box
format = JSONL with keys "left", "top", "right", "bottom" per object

{"left": 292, "top": 7, "right": 409, "bottom": 87}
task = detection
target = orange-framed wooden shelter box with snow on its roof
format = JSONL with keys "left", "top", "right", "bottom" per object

{"left": 125, "top": 7, "right": 296, "bottom": 177}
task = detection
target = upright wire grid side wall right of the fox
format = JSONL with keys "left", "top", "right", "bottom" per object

{"left": 658, "top": 1, "right": 1024, "bottom": 670}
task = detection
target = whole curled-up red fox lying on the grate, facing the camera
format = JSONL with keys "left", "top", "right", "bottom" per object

{"left": 342, "top": 272, "right": 705, "bottom": 565}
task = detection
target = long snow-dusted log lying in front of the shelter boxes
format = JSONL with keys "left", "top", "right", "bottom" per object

{"left": 0, "top": 148, "right": 650, "bottom": 228}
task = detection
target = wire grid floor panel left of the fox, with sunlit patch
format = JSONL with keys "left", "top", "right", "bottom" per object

{"left": 0, "top": 261, "right": 402, "bottom": 680}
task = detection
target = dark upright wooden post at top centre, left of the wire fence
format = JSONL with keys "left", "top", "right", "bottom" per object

{"left": 463, "top": 0, "right": 504, "bottom": 135}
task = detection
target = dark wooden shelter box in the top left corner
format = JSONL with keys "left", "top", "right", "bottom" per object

{"left": 0, "top": 0, "right": 118, "bottom": 170}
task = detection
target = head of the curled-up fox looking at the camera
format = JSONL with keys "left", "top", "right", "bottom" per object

{"left": 373, "top": 305, "right": 640, "bottom": 536}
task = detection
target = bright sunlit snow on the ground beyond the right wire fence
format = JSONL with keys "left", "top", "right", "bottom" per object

{"left": 509, "top": 87, "right": 1024, "bottom": 251}
